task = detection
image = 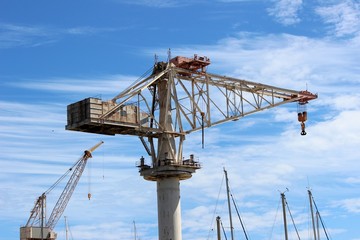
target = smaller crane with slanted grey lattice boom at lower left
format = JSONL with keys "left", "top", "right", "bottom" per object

{"left": 20, "top": 141, "right": 104, "bottom": 240}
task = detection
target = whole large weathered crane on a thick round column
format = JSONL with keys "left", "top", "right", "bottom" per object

{"left": 66, "top": 55, "right": 317, "bottom": 240}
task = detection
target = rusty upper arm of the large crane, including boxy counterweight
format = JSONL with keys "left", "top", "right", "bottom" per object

{"left": 66, "top": 55, "right": 317, "bottom": 164}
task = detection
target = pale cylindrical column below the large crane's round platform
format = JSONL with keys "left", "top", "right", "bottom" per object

{"left": 157, "top": 177, "right": 182, "bottom": 240}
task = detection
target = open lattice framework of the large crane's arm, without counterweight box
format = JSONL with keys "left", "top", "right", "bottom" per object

{"left": 100, "top": 64, "right": 317, "bottom": 137}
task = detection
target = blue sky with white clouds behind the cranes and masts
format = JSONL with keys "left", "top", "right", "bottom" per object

{"left": 0, "top": 0, "right": 360, "bottom": 240}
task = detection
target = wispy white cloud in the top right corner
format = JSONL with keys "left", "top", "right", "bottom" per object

{"left": 316, "top": 0, "right": 360, "bottom": 37}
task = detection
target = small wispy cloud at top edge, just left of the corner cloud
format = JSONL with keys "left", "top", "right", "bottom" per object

{"left": 268, "top": 0, "right": 303, "bottom": 26}
